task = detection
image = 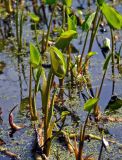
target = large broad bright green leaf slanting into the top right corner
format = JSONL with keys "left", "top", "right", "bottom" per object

{"left": 100, "top": 3, "right": 122, "bottom": 29}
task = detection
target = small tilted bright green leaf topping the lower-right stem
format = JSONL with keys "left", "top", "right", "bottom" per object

{"left": 84, "top": 98, "right": 98, "bottom": 112}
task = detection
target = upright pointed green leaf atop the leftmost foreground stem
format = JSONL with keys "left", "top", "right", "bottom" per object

{"left": 30, "top": 43, "right": 41, "bottom": 68}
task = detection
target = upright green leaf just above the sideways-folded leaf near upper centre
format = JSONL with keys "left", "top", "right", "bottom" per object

{"left": 68, "top": 15, "right": 77, "bottom": 31}
